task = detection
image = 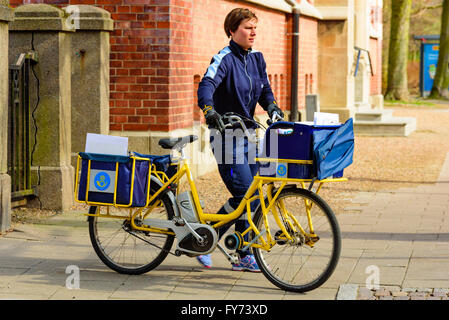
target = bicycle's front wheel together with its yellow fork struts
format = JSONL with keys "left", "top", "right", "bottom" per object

{"left": 252, "top": 189, "right": 341, "bottom": 292}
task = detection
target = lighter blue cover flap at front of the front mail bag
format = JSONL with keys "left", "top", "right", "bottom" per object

{"left": 313, "top": 118, "right": 354, "bottom": 180}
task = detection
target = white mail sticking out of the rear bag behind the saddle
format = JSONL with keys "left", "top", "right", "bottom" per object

{"left": 85, "top": 133, "right": 128, "bottom": 156}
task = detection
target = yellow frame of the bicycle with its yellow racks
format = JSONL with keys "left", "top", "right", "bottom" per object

{"left": 75, "top": 119, "right": 347, "bottom": 250}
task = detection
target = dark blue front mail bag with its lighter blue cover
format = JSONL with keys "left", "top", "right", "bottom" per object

{"left": 259, "top": 119, "right": 354, "bottom": 180}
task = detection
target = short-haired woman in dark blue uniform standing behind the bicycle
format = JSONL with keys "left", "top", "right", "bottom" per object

{"left": 197, "top": 8, "right": 284, "bottom": 272}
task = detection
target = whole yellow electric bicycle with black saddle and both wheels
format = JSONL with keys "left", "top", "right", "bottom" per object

{"left": 75, "top": 114, "right": 346, "bottom": 292}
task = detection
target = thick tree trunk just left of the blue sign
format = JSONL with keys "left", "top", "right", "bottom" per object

{"left": 385, "top": 0, "right": 412, "bottom": 101}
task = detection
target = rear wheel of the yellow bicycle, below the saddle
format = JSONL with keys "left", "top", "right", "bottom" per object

{"left": 88, "top": 190, "right": 175, "bottom": 275}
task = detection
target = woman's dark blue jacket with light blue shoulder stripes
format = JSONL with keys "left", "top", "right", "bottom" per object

{"left": 198, "top": 40, "right": 275, "bottom": 125}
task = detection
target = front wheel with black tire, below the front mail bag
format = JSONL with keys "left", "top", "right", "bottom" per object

{"left": 252, "top": 189, "right": 341, "bottom": 292}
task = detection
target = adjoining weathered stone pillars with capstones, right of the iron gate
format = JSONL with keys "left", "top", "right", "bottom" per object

{"left": 9, "top": 4, "right": 112, "bottom": 211}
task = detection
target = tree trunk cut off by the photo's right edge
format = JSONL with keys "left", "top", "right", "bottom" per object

{"left": 429, "top": 0, "right": 449, "bottom": 99}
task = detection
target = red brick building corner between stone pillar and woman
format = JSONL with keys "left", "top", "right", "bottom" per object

{"left": 107, "top": 0, "right": 194, "bottom": 153}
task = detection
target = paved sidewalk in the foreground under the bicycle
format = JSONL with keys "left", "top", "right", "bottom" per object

{"left": 0, "top": 154, "right": 449, "bottom": 300}
